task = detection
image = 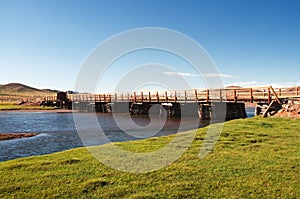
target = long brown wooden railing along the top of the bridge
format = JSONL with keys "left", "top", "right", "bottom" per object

{"left": 45, "top": 86, "right": 300, "bottom": 103}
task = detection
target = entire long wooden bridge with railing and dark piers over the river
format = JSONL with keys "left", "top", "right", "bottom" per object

{"left": 44, "top": 86, "right": 300, "bottom": 119}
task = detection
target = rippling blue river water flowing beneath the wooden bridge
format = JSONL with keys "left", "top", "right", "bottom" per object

{"left": 0, "top": 109, "right": 254, "bottom": 161}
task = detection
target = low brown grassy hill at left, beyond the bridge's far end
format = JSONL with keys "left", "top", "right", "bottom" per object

{"left": 0, "top": 83, "right": 57, "bottom": 101}
